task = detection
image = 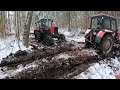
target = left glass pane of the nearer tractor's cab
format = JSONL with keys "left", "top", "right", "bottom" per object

{"left": 91, "top": 17, "right": 102, "bottom": 30}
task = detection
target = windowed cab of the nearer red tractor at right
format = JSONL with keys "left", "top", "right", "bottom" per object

{"left": 90, "top": 14, "right": 117, "bottom": 32}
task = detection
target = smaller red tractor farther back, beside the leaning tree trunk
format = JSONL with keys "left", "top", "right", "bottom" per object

{"left": 34, "top": 19, "right": 65, "bottom": 46}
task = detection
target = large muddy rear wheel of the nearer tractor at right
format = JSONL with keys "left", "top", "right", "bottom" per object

{"left": 99, "top": 34, "right": 114, "bottom": 55}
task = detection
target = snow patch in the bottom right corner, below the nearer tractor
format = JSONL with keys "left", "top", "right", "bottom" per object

{"left": 74, "top": 58, "right": 120, "bottom": 79}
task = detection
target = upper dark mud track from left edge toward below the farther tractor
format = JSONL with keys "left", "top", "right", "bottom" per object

{"left": 0, "top": 43, "right": 74, "bottom": 67}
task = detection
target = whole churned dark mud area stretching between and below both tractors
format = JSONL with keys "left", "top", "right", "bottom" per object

{"left": 0, "top": 35, "right": 118, "bottom": 79}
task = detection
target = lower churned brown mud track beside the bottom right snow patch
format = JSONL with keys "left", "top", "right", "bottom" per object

{"left": 3, "top": 50, "right": 98, "bottom": 79}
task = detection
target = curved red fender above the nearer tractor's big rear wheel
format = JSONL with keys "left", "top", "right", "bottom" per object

{"left": 95, "top": 30, "right": 114, "bottom": 43}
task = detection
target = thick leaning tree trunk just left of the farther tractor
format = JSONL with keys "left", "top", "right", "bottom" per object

{"left": 23, "top": 11, "right": 33, "bottom": 47}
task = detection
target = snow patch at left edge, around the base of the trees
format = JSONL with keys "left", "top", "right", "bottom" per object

{"left": 0, "top": 35, "right": 31, "bottom": 62}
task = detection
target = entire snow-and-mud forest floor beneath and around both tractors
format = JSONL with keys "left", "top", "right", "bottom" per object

{"left": 0, "top": 30, "right": 120, "bottom": 79}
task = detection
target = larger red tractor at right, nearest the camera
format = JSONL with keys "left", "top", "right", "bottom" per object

{"left": 85, "top": 14, "right": 120, "bottom": 55}
